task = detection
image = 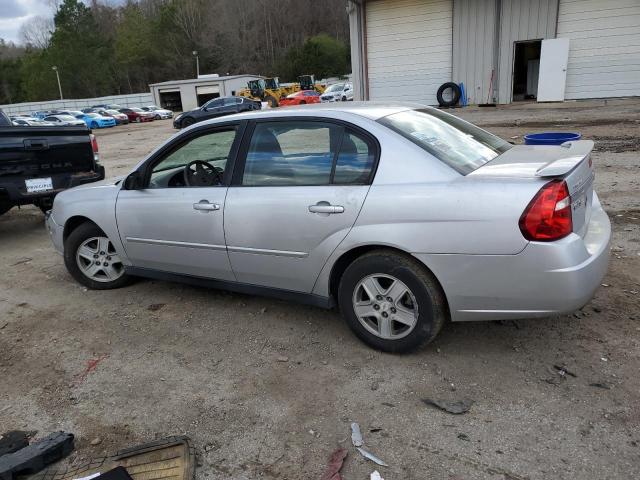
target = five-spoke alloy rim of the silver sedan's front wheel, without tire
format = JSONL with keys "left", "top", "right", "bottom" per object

{"left": 76, "top": 237, "right": 124, "bottom": 283}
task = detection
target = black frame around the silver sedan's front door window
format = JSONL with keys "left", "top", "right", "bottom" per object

{"left": 138, "top": 120, "right": 247, "bottom": 190}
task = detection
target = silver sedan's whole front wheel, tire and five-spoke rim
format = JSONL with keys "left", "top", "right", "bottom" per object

{"left": 64, "top": 222, "right": 131, "bottom": 290}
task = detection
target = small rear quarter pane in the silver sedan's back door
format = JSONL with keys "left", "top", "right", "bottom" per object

{"left": 333, "top": 130, "right": 375, "bottom": 185}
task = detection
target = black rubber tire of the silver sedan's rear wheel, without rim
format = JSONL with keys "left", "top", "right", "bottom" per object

{"left": 338, "top": 250, "right": 448, "bottom": 353}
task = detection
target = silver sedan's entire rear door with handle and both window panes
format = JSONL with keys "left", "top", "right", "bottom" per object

{"left": 224, "top": 118, "right": 378, "bottom": 292}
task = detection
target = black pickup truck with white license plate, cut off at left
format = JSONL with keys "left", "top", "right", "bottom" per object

{"left": 0, "top": 110, "right": 104, "bottom": 215}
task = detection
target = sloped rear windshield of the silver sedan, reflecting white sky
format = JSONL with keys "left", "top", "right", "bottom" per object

{"left": 379, "top": 108, "right": 511, "bottom": 175}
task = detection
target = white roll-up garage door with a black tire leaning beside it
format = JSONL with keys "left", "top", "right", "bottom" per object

{"left": 365, "top": 0, "right": 453, "bottom": 105}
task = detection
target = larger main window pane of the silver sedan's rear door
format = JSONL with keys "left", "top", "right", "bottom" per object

{"left": 242, "top": 121, "right": 342, "bottom": 186}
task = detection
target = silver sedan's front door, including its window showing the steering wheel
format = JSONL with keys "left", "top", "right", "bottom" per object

{"left": 116, "top": 125, "right": 238, "bottom": 280}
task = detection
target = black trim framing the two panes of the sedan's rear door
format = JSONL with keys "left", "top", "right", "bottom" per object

{"left": 229, "top": 116, "right": 381, "bottom": 188}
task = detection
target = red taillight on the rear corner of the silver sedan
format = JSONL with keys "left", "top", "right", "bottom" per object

{"left": 519, "top": 180, "right": 573, "bottom": 242}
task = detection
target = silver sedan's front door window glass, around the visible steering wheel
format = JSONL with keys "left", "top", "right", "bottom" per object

{"left": 149, "top": 127, "right": 237, "bottom": 188}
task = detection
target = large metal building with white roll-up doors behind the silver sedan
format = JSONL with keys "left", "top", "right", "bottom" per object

{"left": 348, "top": 0, "right": 640, "bottom": 104}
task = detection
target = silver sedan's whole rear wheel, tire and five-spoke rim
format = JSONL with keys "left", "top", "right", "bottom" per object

{"left": 338, "top": 250, "right": 447, "bottom": 353}
